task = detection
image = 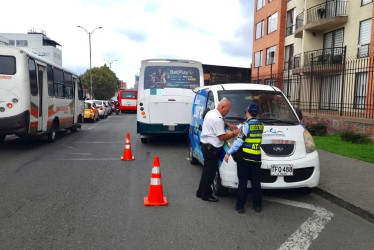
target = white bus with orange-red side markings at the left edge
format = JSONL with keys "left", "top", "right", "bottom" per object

{"left": 0, "top": 46, "right": 84, "bottom": 142}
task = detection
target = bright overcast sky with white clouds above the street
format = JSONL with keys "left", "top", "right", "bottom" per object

{"left": 0, "top": 0, "right": 254, "bottom": 86}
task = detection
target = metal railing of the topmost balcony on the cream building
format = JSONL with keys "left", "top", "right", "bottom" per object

{"left": 306, "top": 0, "right": 348, "bottom": 24}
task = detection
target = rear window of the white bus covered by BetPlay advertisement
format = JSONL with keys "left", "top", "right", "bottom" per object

{"left": 144, "top": 66, "right": 200, "bottom": 89}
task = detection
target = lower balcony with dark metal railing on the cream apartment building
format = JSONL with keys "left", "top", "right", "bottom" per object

{"left": 292, "top": 47, "right": 346, "bottom": 75}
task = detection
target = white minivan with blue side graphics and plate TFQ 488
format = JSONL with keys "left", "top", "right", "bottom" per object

{"left": 189, "top": 83, "right": 320, "bottom": 196}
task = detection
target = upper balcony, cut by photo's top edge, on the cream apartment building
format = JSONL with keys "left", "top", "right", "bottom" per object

{"left": 295, "top": 0, "right": 348, "bottom": 37}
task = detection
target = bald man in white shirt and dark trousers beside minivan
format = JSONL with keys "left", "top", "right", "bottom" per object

{"left": 196, "top": 99, "right": 240, "bottom": 202}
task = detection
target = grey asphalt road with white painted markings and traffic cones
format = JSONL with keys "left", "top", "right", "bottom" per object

{"left": 0, "top": 114, "right": 374, "bottom": 250}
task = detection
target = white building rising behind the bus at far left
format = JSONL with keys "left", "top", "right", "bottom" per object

{"left": 0, "top": 30, "right": 62, "bottom": 66}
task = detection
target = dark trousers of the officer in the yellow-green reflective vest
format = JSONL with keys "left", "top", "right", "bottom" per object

{"left": 236, "top": 161, "right": 262, "bottom": 208}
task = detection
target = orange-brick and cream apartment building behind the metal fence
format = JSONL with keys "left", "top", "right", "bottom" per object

{"left": 252, "top": 0, "right": 374, "bottom": 137}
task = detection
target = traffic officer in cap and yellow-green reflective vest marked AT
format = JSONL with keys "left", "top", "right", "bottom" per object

{"left": 225, "top": 103, "right": 264, "bottom": 213}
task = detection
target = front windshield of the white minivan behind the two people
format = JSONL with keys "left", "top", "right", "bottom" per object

{"left": 218, "top": 90, "right": 299, "bottom": 125}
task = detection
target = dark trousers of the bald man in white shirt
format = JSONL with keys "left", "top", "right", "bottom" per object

{"left": 196, "top": 143, "right": 222, "bottom": 198}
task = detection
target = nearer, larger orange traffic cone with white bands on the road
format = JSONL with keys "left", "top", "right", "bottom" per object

{"left": 144, "top": 156, "right": 168, "bottom": 206}
